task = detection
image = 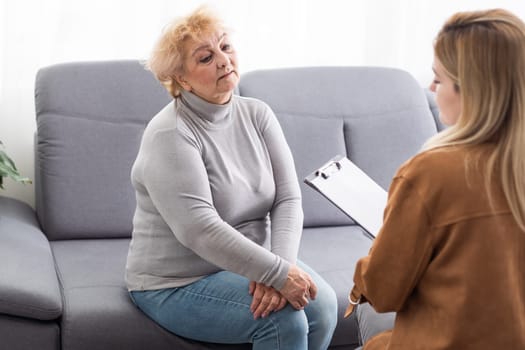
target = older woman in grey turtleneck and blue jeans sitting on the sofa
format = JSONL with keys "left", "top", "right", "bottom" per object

{"left": 126, "top": 8, "right": 337, "bottom": 350}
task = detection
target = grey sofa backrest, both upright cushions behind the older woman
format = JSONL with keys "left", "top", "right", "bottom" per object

{"left": 35, "top": 60, "right": 436, "bottom": 240}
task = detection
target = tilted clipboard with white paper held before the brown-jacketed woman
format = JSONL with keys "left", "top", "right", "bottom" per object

{"left": 304, "top": 155, "right": 388, "bottom": 239}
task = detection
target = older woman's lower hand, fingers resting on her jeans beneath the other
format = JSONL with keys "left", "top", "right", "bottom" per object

{"left": 249, "top": 281, "right": 287, "bottom": 319}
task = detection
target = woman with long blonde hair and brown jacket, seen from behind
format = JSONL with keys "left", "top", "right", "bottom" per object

{"left": 350, "top": 9, "right": 525, "bottom": 350}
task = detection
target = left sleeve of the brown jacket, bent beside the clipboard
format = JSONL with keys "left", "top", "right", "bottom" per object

{"left": 351, "top": 177, "right": 432, "bottom": 312}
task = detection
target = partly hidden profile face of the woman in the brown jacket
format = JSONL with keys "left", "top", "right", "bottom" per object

{"left": 430, "top": 58, "right": 461, "bottom": 125}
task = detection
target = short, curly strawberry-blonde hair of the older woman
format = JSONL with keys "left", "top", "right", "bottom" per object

{"left": 145, "top": 6, "right": 226, "bottom": 97}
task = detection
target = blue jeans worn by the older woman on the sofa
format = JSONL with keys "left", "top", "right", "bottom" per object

{"left": 130, "top": 263, "right": 337, "bottom": 350}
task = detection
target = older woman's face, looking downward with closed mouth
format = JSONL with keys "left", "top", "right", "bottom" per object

{"left": 177, "top": 32, "right": 239, "bottom": 104}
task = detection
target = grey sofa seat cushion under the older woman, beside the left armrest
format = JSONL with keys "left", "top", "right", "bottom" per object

{"left": 51, "top": 239, "right": 249, "bottom": 350}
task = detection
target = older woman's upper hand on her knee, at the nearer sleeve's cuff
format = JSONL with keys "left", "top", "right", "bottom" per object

{"left": 280, "top": 265, "right": 317, "bottom": 310}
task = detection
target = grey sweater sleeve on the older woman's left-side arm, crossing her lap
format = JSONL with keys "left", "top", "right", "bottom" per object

{"left": 144, "top": 119, "right": 289, "bottom": 289}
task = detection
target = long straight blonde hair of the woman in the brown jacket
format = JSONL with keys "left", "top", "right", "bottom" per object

{"left": 423, "top": 9, "right": 525, "bottom": 231}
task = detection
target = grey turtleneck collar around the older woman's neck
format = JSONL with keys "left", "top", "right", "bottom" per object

{"left": 180, "top": 90, "right": 232, "bottom": 124}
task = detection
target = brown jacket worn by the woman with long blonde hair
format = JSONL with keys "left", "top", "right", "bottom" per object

{"left": 352, "top": 145, "right": 525, "bottom": 350}
